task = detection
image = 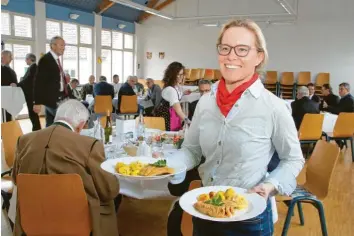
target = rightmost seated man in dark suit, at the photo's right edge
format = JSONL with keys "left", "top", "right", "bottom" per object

{"left": 327, "top": 82, "right": 354, "bottom": 114}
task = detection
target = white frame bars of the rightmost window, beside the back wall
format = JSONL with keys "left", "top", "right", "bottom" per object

{"left": 99, "top": 28, "right": 136, "bottom": 83}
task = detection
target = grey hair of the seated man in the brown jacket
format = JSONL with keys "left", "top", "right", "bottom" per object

{"left": 54, "top": 99, "right": 89, "bottom": 129}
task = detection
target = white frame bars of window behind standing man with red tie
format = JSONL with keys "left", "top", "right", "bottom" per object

{"left": 45, "top": 18, "right": 95, "bottom": 85}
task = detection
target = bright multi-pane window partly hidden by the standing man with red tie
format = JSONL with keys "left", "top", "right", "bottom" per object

{"left": 46, "top": 20, "right": 93, "bottom": 84}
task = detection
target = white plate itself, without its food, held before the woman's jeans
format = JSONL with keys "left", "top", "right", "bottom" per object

{"left": 179, "top": 186, "right": 267, "bottom": 222}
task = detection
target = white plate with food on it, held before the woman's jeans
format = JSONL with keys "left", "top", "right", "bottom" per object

{"left": 179, "top": 186, "right": 267, "bottom": 222}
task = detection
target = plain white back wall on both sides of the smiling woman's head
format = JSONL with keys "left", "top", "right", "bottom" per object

{"left": 136, "top": 0, "right": 354, "bottom": 92}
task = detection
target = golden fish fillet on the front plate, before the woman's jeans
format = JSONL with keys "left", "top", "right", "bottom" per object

{"left": 194, "top": 201, "right": 235, "bottom": 218}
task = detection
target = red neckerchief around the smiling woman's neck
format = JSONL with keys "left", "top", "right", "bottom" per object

{"left": 216, "top": 73, "right": 258, "bottom": 117}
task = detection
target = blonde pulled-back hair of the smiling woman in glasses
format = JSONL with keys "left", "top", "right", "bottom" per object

{"left": 217, "top": 19, "right": 268, "bottom": 71}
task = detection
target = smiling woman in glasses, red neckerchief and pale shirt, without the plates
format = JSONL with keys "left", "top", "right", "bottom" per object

{"left": 176, "top": 20, "right": 304, "bottom": 236}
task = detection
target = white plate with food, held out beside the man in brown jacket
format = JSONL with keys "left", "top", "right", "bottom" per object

{"left": 101, "top": 156, "right": 187, "bottom": 180}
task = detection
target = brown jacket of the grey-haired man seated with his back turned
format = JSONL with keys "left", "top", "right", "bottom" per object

{"left": 12, "top": 124, "right": 119, "bottom": 236}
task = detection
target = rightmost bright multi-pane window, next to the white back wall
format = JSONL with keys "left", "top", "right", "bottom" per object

{"left": 101, "top": 30, "right": 134, "bottom": 82}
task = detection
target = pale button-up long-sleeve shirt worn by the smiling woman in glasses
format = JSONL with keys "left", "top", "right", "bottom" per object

{"left": 176, "top": 79, "right": 304, "bottom": 195}
